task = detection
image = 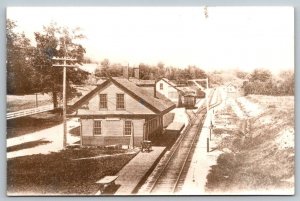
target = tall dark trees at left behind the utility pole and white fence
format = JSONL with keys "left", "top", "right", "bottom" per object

{"left": 6, "top": 19, "right": 88, "bottom": 107}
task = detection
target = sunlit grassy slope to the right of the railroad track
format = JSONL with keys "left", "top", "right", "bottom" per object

{"left": 206, "top": 95, "right": 295, "bottom": 193}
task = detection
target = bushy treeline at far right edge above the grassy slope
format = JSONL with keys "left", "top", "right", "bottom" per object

{"left": 241, "top": 69, "right": 295, "bottom": 96}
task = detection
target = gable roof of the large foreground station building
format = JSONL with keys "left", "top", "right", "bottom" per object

{"left": 71, "top": 77, "right": 175, "bottom": 113}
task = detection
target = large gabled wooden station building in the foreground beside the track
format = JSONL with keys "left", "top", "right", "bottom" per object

{"left": 69, "top": 78, "right": 175, "bottom": 146}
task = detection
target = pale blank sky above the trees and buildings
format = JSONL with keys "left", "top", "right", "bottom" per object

{"left": 7, "top": 7, "right": 294, "bottom": 72}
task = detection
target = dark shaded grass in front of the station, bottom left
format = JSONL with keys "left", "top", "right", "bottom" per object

{"left": 7, "top": 148, "right": 136, "bottom": 195}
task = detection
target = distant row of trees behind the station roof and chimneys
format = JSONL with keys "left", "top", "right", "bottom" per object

{"left": 95, "top": 59, "right": 207, "bottom": 84}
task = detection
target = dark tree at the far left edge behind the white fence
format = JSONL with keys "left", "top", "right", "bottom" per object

{"left": 6, "top": 19, "right": 38, "bottom": 94}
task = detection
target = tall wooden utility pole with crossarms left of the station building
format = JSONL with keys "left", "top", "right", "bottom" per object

{"left": 52, "top": 40, "right": 77, "bottom": 148}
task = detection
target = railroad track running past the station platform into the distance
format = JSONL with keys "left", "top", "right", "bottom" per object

{"left": 148, "top": 90, "right": 219, "bottom": 195}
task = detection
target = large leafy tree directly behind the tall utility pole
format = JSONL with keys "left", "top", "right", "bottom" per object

{"left": 34, "top": 23, "right": 87, "bottom": 108}
